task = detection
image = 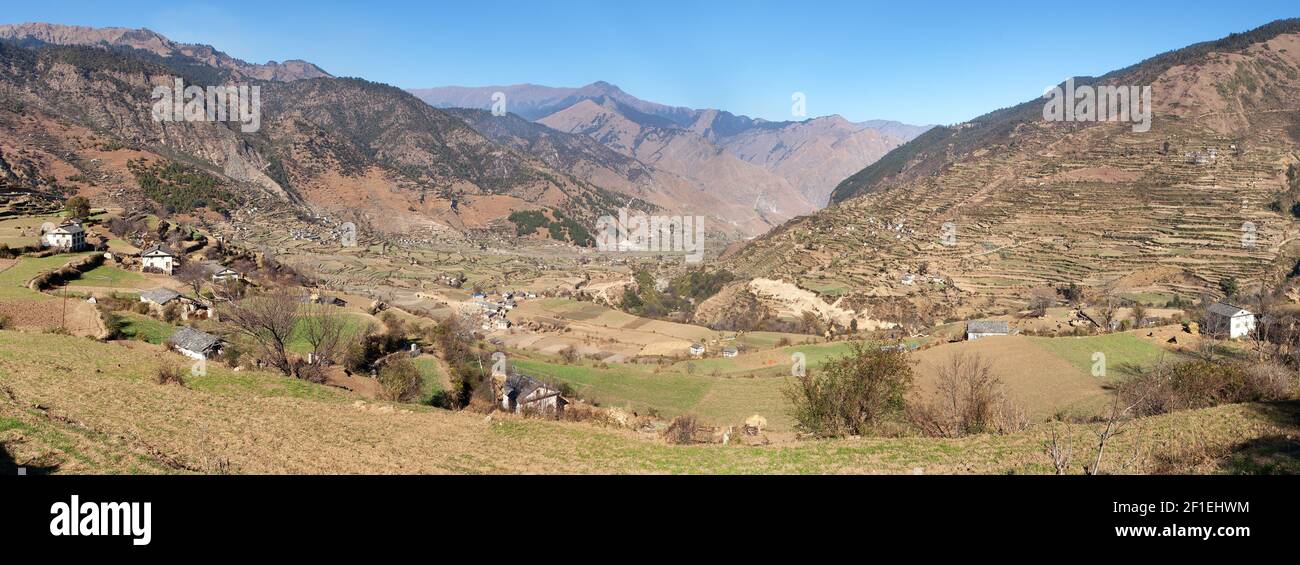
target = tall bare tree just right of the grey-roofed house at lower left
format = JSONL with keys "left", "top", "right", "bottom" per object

{"left": 222, "top": 291, "right": 302, "bottom": 375}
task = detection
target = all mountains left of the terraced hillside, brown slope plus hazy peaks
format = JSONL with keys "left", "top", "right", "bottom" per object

{"left": 0, "top": 23, "right": 926, "bottom": 236}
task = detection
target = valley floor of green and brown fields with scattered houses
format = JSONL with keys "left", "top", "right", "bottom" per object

{"left": 0, "top": 190, "right": 1294, "bottom": 471}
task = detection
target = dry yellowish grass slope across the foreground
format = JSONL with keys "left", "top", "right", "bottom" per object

{"left": 0, "top": 331, "right": 1300, "bottom": 474}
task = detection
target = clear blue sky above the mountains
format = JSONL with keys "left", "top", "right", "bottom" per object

{"left": 0, "top": 0, "right": 1300, "bottom": 123}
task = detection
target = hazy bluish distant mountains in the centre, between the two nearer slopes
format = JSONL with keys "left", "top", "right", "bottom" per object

{"left": 410, "top": 82, "right": 928, "bottom": 213}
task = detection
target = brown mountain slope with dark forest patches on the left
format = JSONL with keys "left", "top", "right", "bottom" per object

{"left": 0, "top": 23, "right": 629, "bottom": 234}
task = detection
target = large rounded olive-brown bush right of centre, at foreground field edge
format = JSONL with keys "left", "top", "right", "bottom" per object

{"left": 785, "top": 343, "right": 913, "bottom": 438}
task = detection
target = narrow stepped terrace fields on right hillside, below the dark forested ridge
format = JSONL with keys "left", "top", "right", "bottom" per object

{"left": 735, "top": 123, "right": 1296, "bottom": 309}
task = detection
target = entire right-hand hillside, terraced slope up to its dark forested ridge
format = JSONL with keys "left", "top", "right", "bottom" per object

{"left": 728, "top": 21, "right": 1300, "bottom": 311}
